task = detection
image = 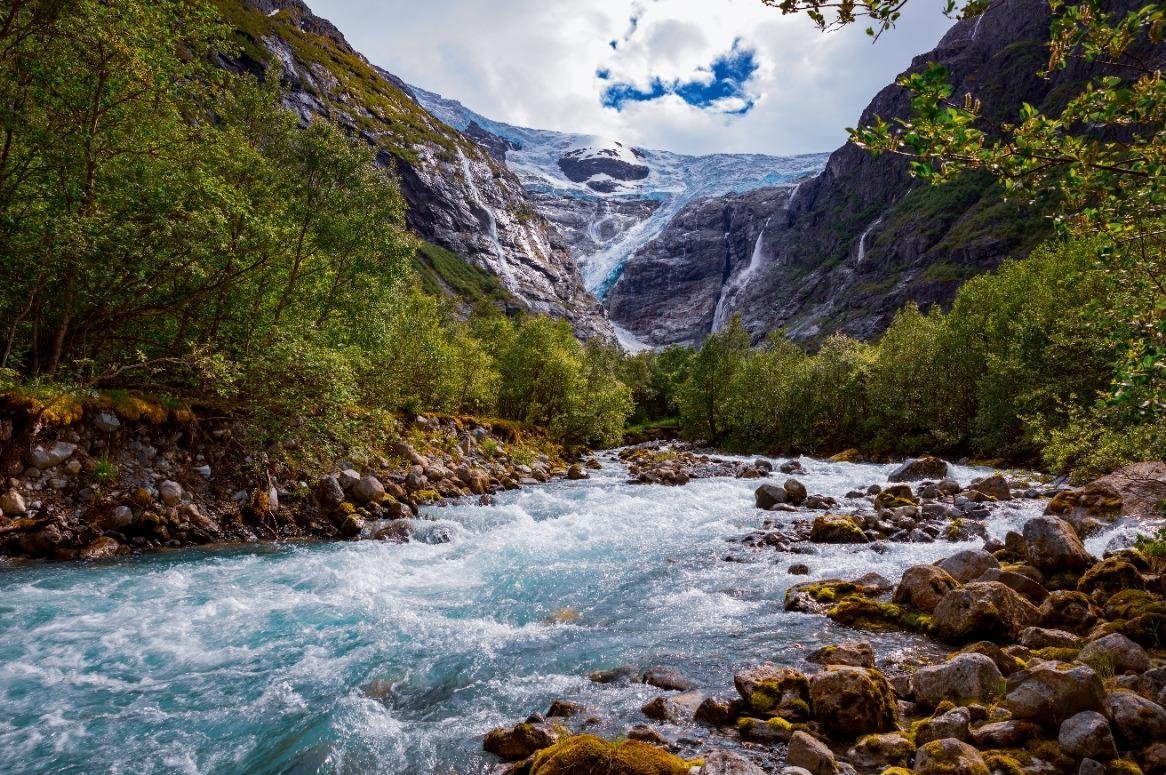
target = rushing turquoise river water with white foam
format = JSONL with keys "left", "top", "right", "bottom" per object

{"left": 0, "top": 460, "right": 1040, "bottom": 773}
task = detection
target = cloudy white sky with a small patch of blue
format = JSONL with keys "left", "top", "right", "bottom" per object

{"left": 307, "top": 0, "right": 951, "bottom": 155}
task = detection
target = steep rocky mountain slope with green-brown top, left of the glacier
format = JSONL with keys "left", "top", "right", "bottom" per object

{"left": 216, "top": 0, "right": 613, "bottom": 338}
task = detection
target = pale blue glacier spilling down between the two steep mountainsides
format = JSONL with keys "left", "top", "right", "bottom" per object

{"left": 409, "top": 86, "right": 827, "bottom": 298}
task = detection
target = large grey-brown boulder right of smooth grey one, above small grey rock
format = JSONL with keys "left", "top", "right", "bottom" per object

{"left": 1002, "top": 662, "right": 1105, "bottom": 727}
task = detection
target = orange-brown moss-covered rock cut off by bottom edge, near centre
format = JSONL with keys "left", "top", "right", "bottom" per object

{"left": 527, "top": 734, "right": 693, "bottom": 775}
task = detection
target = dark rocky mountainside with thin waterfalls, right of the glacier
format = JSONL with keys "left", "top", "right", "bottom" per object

{"left": 606, "top": 0, "right": 1124, "bottom": 344}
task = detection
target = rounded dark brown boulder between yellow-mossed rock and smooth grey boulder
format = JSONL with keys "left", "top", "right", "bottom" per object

{"left": 809, "top": 667, "right": 897, "bottom": 737}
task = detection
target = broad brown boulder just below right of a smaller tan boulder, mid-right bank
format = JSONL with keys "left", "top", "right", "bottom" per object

{"left": 932, "top": 582, "right": 1040, "bottom": 643}
